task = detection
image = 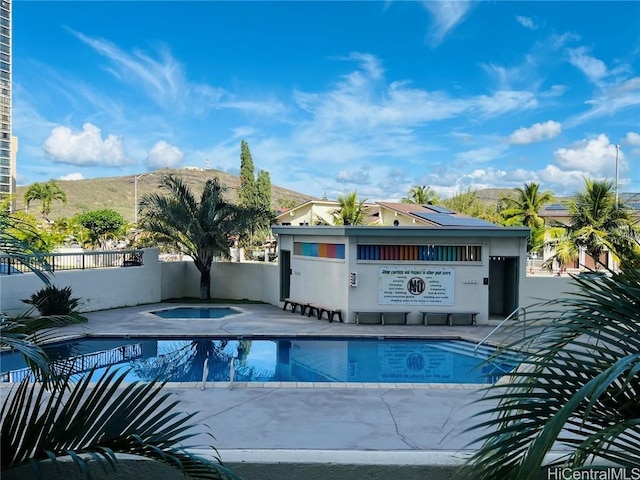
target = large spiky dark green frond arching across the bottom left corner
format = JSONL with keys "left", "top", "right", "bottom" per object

{"left": 0, "top": 369, "right": 239, "bottom": 480}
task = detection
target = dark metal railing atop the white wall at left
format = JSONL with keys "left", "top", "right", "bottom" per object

{"left": 0, "top": 250, "right": 144, "bottom": 275}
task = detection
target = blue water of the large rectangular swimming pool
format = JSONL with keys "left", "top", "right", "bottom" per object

{"left": 0, "top": 338, "right": 517, "bottom": 383}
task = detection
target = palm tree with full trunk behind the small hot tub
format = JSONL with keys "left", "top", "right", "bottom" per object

{"left": 140, "top": 175, "right": 268, "bottom": 299}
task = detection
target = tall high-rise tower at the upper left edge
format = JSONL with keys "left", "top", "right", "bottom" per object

{"left": 0, "top": 0, "right": 10, "bottom": 210}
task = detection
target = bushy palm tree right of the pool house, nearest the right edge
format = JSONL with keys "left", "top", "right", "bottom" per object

{"left": 550, "top": 178, "right": 638, "bottom": 270}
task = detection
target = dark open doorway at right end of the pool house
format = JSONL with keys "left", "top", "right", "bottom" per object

{"left": 489, "top": 257, "right": 518, "bottom": 318}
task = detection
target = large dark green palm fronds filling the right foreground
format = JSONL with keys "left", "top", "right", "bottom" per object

{"left": 467, "top": 243, "right": 640, "bottom": 480}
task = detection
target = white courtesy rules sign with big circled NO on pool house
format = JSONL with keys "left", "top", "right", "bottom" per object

{"left": 378, "top": 265, "right": 455, "bottom": 306}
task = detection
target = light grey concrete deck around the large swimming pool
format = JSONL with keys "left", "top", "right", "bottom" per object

{"left": 5, "top": 303, "right": 524, "bottom": 479}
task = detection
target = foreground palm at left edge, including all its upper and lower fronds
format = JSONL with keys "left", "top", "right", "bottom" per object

{"left": 0, "top": 215, "right": 239, "bottom": 480}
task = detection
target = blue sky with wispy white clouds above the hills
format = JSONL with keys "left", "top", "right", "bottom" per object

{"left": 13, "top": 0, "right": 640, "bottom": 200}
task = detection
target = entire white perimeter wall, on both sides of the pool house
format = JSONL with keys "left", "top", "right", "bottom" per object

{"left": 0, "top": 248, "right": 577, "bottom": 315}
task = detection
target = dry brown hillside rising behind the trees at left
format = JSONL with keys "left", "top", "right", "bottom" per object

{"left": 16, "top": 169, "right": 315, "bottom": 221}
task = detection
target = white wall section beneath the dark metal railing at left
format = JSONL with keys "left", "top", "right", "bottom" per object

{"left": 0, "top": 248, "right": 161, "bottom": 315}
